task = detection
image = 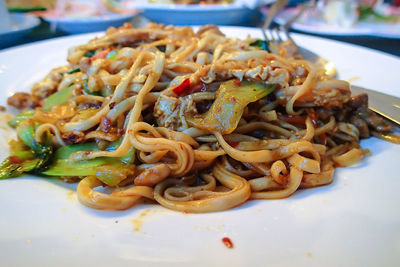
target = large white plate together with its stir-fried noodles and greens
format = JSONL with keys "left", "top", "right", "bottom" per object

{"left": 0, "top": 24, "right": 400, "bottom": 266}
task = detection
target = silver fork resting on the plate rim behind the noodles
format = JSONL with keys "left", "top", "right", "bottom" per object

{"left": 261, "top": 0, "right": 337, "bottom": 78}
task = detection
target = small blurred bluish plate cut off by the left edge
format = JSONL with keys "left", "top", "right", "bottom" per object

{"left": 0, "top": 13, "right": 40, "bottom": 48}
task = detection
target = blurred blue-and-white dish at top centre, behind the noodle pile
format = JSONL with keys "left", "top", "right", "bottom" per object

{"left": 130, "top": 0, "right": 275, "bottom": 25}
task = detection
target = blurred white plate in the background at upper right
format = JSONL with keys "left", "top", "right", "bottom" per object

{"left": 275, "top": 8, "right": 400, "bottom": 39}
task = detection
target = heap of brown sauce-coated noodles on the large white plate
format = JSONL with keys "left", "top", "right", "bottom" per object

{"left": 4, "top": 24, "right": 390, "bottom": 212}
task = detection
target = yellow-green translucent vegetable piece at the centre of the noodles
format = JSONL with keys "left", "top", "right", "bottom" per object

{"left": 186, "top": 80, "right": 275, "bottom": 134}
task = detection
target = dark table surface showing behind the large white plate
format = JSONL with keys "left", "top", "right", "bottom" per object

{"left": 0, "top": 16, "right": 400, "bottom": 57}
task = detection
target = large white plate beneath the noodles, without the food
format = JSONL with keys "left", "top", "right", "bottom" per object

{"left": 0, "top": 27, "right": 400, "bottom": 266}
